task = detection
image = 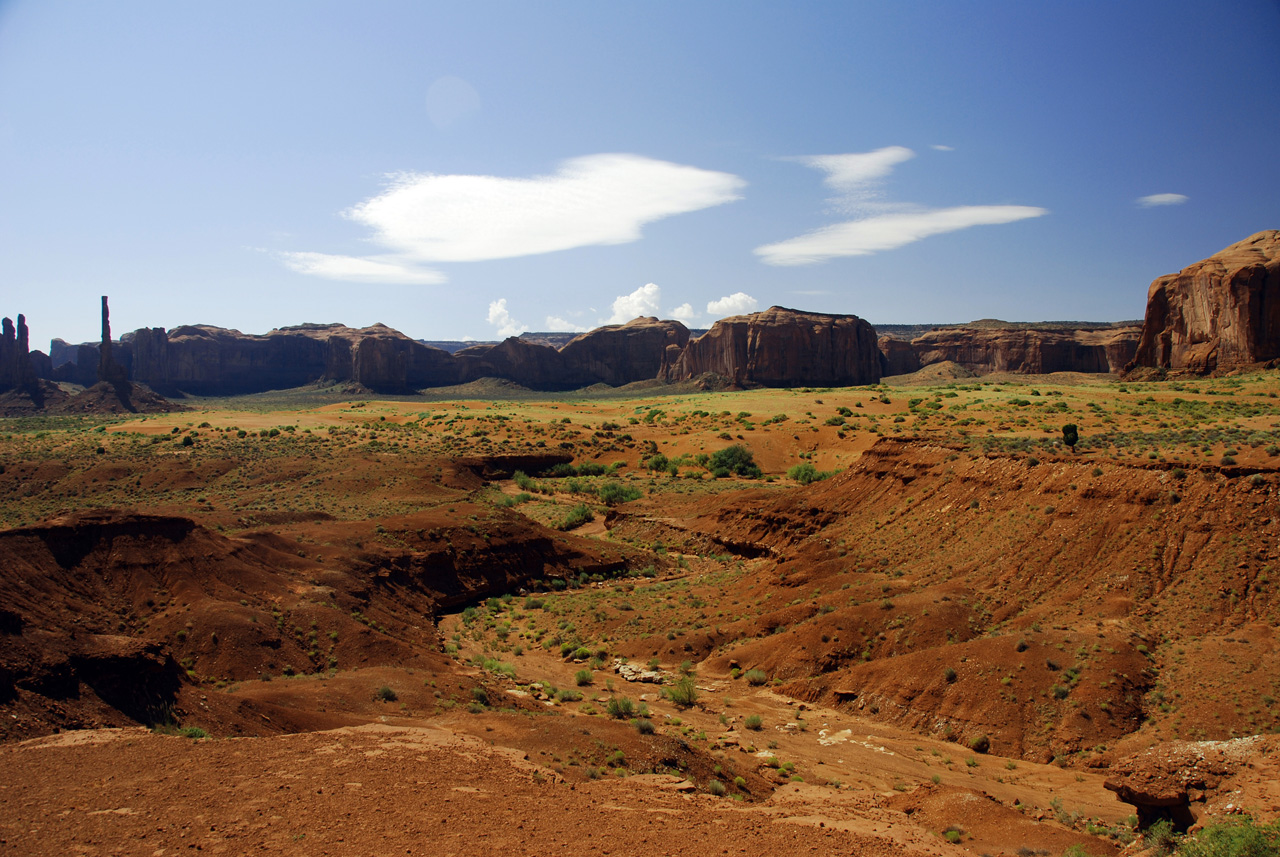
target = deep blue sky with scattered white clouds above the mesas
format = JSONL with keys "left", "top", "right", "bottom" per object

{"left": 0, "top": 0, "right": 1280, "bottom": 348}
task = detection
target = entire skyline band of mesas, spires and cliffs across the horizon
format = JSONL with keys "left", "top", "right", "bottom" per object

{"left": 20, "top": 230, "right": 1280, "bottom": 413}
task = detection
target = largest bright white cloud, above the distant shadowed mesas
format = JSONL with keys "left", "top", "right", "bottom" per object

{"left": 347, "top": 155, "right": 745, "bottom": 262}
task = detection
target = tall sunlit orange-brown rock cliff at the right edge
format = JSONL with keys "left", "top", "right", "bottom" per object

{"left": 1132, "top": 229, "right": 1280, "bottom": 372}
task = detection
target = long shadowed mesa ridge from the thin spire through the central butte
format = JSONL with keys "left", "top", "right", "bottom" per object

{"left": 54, "top": 307, "right": 882, "bottom": 395}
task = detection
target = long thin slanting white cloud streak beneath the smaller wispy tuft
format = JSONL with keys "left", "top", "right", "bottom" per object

{"left": 755, "top": 206, "right": 1048, "bottom": 265}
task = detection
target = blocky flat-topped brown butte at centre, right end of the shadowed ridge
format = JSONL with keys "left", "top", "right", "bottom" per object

{"left": 663, "top": 307, "right": 881, "bottom": 386}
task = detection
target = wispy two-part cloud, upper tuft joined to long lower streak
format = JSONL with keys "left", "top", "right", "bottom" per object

{"left": 755, "top": 146, "right": 1048, "bottom": 265}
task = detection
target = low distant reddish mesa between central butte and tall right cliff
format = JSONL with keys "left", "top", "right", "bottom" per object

{"left": 901, "top": 322, "right": 1139, "bottom": 375}
